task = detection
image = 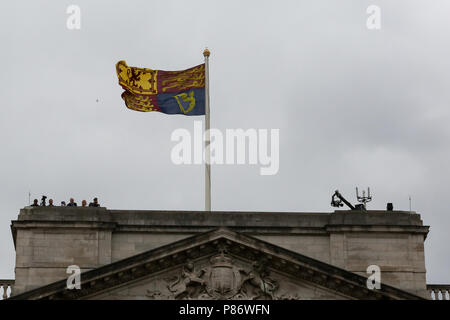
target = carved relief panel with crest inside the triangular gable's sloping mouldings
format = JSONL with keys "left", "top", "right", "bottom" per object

{"left": 89, "top": 251, "right": 352, "bottom": 300}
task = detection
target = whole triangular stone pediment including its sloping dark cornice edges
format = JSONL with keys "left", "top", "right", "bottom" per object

{"left": 13, "top": 228, "right": 421, "bottom": 300}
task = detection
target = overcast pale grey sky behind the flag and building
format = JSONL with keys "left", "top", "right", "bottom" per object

{"left": 0, "top": 0, "right": 450, "bottom": 283}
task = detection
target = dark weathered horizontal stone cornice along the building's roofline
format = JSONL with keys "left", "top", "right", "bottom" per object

{"left": 11, "top": 207, "right": 429, "bottom": 242}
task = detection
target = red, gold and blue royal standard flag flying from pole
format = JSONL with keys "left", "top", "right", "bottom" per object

{"left": 116, "top": 61, "right": 205, "bottom": 116}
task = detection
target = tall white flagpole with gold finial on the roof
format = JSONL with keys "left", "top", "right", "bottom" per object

{"left": 203, "top": 48, "right": 211, "bottom": 212}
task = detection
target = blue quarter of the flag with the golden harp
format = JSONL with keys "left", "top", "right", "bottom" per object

{"left": 157, "top": 88, "right": 205, "bottom": 116}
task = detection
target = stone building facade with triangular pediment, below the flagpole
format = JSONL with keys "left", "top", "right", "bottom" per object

{"left": 6, "top": 207, "right": 429, "bottom": 299}
